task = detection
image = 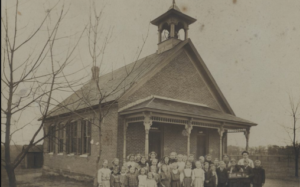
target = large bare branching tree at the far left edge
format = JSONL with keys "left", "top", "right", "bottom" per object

{"left": 1, "top": 0, "right": 85, "bottom": 187}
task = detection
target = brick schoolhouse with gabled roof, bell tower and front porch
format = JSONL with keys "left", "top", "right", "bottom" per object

{"left": 43, "top": 1, "right": 256, "bottom": 179}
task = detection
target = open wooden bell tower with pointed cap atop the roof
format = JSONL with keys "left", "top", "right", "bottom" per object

{"left": 151, "top": 0, "right": 196, "bottom": 54}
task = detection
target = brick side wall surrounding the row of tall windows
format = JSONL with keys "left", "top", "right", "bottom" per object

{"left": 43, "top": 106, "right": 118, "bottom": 176}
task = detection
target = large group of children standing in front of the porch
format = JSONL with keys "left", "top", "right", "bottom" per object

{"left": 98, "top": 152, "right": 265, "bottom": 187}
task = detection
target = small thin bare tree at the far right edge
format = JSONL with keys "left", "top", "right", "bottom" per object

{"left": 283, "top": 96, "right": 300, "bottom": 177}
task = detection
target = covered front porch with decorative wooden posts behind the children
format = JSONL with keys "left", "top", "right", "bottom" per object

{"left": 119, "top": 96, "right": 256, "bottom": 161}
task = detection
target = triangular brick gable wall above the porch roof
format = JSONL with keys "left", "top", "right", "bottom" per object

{"left": 119, "top": 52, "right": 220, "bottom": 110}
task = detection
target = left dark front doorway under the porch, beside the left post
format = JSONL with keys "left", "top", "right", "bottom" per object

{"left": 149, "top": 130, "right": 161, "bottom": 159}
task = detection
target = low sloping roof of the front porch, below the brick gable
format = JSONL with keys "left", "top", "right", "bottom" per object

{"left": 119, "top": 96, "right": 257, "bottom": 126}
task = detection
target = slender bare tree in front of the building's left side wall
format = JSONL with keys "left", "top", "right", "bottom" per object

{"left": 46, "top": 1, "right": 149, "bottom": 186}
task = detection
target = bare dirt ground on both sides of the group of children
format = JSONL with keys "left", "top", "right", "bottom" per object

{"left": 1, "top": 170, "right": 300, "bottom": 187}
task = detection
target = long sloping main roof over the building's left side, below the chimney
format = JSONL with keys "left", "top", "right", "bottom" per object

{"left": 48, "top": 47, "right": 177, "bottom": 118}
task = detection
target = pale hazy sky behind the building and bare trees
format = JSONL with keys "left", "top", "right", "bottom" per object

{"left": 1, "top": 0, "right": 300, "bottom": 146}
